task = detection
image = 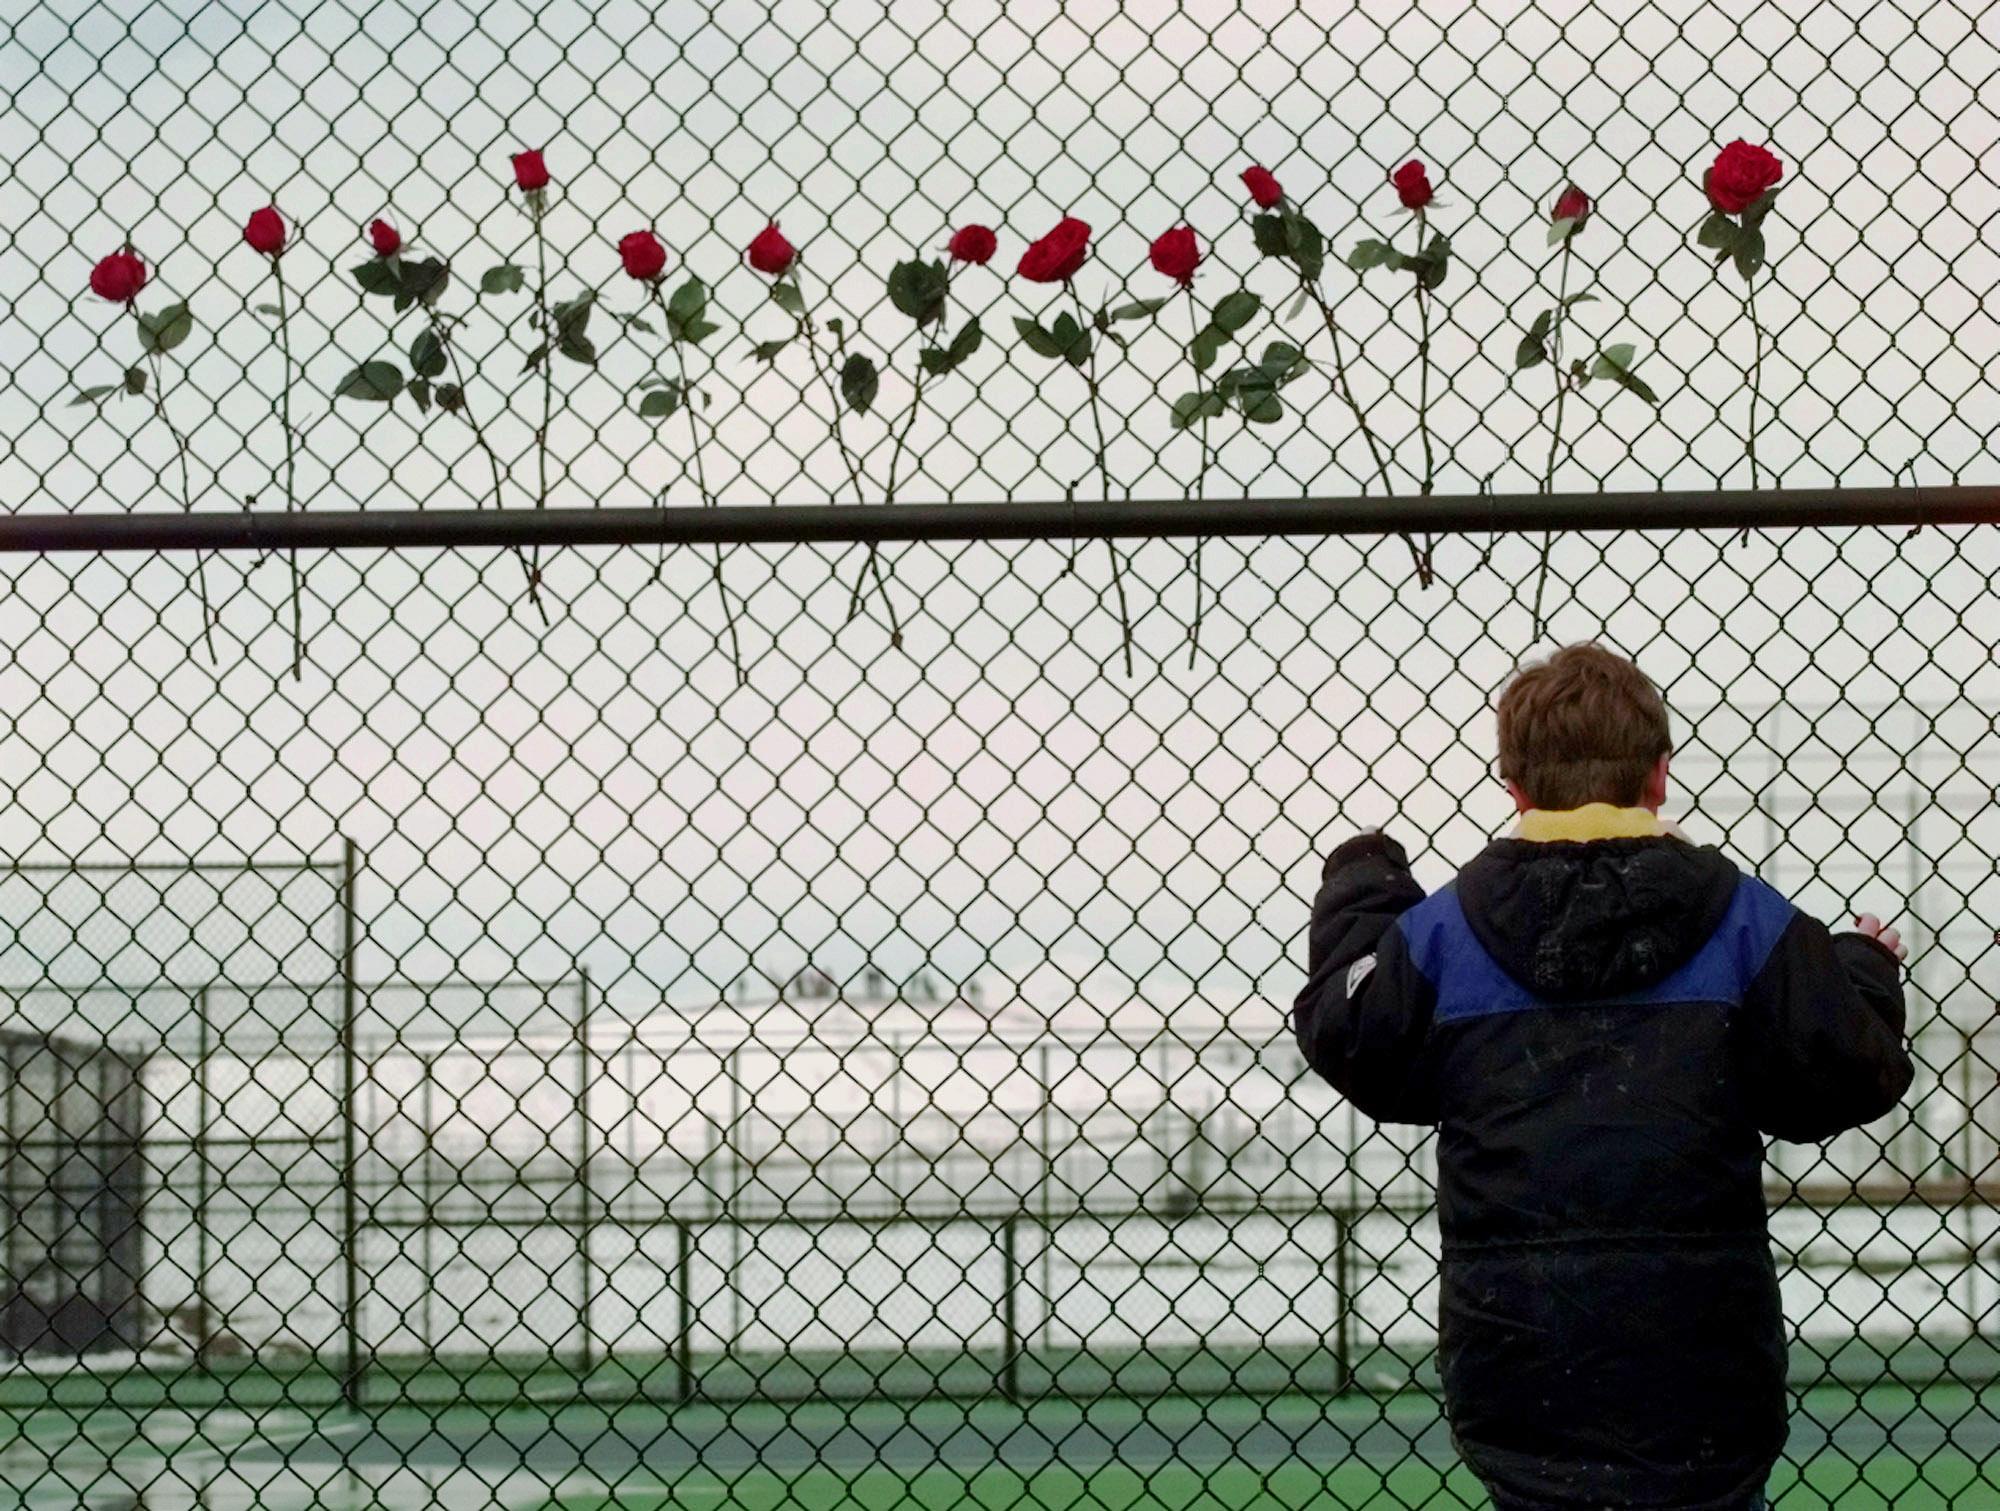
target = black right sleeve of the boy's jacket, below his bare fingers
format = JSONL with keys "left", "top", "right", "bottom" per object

{"left": 1742, "top": 913, "right": 1912, "bottom": 1143}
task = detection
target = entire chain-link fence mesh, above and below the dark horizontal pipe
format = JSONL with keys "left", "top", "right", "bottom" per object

{"left": 0, "top": 0, "right": 2000, "bottom": 1511}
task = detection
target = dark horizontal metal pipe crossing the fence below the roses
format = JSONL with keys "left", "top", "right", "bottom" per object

{"left": 0, "top": 486, "right": 2000, "bottom": 552}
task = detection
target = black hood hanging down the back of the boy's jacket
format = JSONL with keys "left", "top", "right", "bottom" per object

{"left": 1458, "top": 835, "right": 1740, "bottom": 1001}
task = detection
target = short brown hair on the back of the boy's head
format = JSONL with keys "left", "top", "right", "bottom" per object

{"left": 1500, "top": 642, "right": 1674, "bottom": 809}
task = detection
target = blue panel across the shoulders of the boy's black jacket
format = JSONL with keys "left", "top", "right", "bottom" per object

{"left": 1396, "top": 875, "right": 1794, "bottom": 1023}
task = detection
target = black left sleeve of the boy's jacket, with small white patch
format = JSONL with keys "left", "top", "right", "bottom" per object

{"left": 1292, "top": 833, "right": 1438, "bottom": 1123}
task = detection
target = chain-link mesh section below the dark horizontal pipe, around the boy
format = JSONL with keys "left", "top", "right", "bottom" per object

{"left": 0, "top": 528, "right": 2000, "bottom": 1507}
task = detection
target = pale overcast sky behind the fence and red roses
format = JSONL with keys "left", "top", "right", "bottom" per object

{"left": 0, "top": 0, "right": 2000, "bottom": 1055}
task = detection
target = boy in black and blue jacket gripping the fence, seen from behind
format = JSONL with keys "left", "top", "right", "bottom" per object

{"left": 1292, "top": 646, "right": 1910, "bottom": 1511}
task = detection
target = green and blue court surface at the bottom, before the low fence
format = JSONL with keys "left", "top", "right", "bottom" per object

{"left": 0, "top": 1385, "right": 2000, "bottom": 1511}
